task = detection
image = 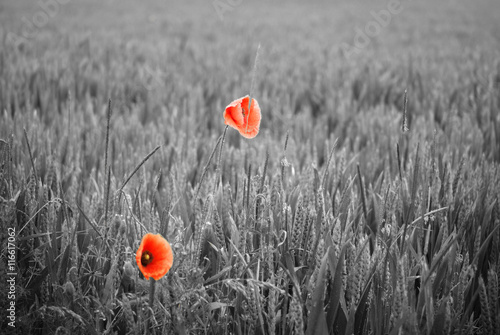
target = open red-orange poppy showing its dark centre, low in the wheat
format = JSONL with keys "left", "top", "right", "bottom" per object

{"left": 135, "top": 233, "right": 174, "bottom": 280}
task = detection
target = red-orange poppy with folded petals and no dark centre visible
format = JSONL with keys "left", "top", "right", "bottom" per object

{"left": 224, "top": 95, "right": 261, "bottom": 138}
